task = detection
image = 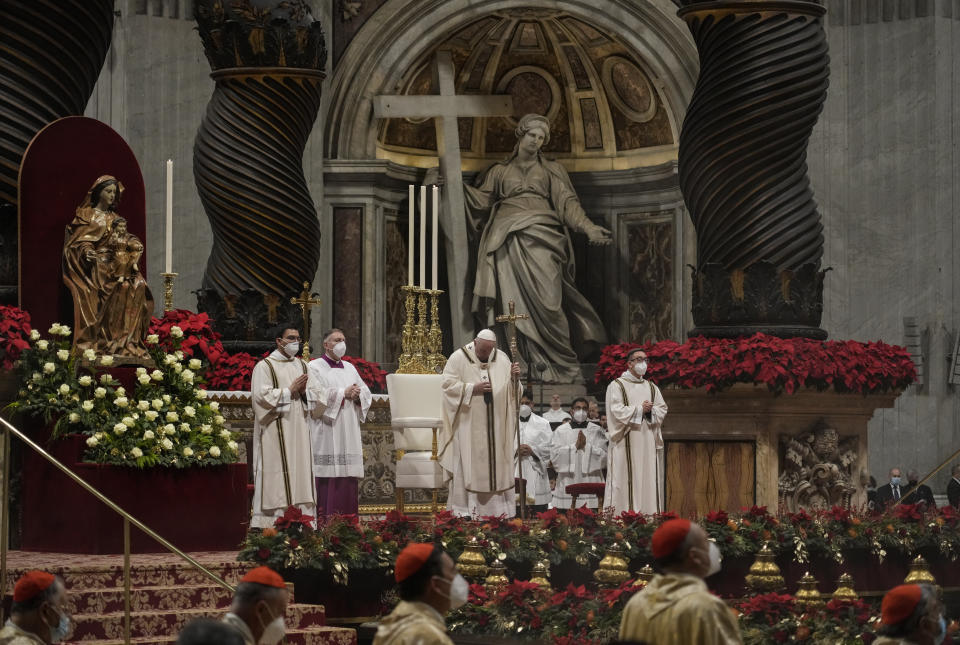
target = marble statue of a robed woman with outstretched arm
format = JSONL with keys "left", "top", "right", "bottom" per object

{"left": 464, "top": 114, "right": 611, "bottom": 383}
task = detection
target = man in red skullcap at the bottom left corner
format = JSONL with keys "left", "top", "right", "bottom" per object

{"left": 0, "top": 571, "right": 72, "bottom": 645}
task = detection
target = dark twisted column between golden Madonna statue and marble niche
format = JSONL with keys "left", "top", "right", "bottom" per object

{"left": 193, "top": 0, "right": 326, "bottom": 300}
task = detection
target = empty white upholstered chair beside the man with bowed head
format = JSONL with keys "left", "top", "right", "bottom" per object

{"left": 387, "top": 374, "right": 444, "bottom": 513}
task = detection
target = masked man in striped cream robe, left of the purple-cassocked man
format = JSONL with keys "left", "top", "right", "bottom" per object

{"left": 250, "top": 325, "right": 324, "bottom": 528}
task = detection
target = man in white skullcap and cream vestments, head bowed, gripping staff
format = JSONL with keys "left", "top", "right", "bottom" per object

{"left": 439, "top": 329, "right": 522, "bottom": 517}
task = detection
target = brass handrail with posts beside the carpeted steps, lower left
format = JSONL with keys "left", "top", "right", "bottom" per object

{"left": 0, "top": 416, "right": 234, "bottom": 645}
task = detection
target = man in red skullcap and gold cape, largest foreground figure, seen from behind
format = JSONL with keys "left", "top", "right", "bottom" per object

{"left": 620, "top": 520, "right": 743, "bottom": 645}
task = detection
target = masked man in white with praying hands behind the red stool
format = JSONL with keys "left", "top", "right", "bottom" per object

{"left": 550, "top": 397, "right": 607, "bottom": 510}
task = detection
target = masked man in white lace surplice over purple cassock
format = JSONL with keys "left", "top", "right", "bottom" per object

{"left": 310, "top": 329, "right": 373, "bottom": 516}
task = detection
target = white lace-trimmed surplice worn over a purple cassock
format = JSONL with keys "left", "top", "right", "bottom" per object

{"left": 310, "top": 357, "right": 373, "bottom": 479}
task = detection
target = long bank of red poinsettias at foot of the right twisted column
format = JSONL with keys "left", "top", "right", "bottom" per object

{"left": 594, "top": 334, "right": 917, "bottom": 394}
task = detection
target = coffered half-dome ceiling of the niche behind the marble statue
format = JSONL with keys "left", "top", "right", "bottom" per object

{"left": 378, "top": 10, "right": 676, "bottom": 170}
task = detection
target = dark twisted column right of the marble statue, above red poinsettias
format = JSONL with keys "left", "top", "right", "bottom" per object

{"left": 679, "top": 0, "right": 829, "bottom": 338}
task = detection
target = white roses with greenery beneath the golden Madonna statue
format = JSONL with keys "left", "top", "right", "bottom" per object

{"left": 10, "top": 323, "right": 238, "bottom": 468}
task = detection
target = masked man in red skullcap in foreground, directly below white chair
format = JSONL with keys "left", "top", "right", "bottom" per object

{"left": 373, "top": 543, "right": 470, "bottom": 645}
